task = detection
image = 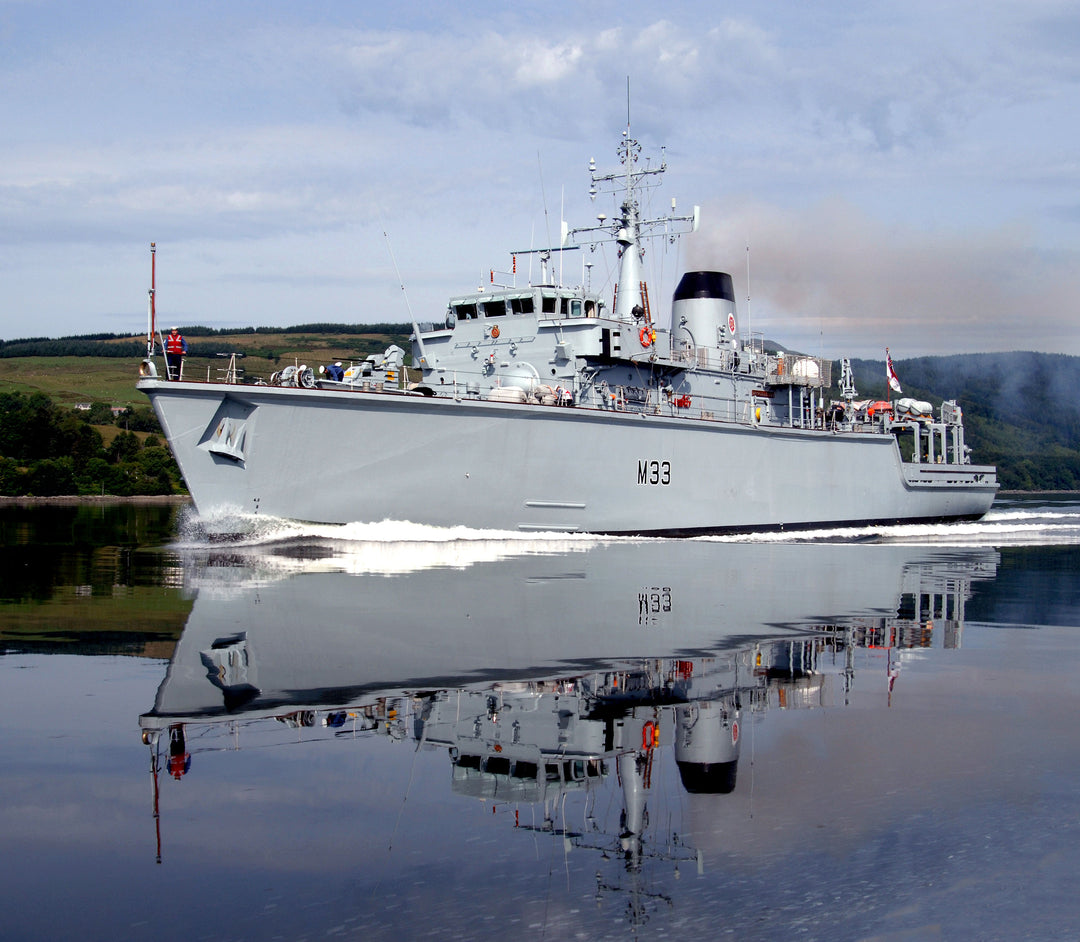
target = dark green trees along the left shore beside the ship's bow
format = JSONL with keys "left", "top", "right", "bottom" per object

{"left": 0, "top": 392, "right": 180, "bottom": 497}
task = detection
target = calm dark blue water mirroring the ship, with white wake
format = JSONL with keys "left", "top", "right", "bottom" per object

{"left": 0, "top": 498, "right": 1080, "bottom": 940}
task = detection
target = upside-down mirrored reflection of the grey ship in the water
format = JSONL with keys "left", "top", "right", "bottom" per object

{"left": 139, "top": 540, "right": 999, "bottom": 928}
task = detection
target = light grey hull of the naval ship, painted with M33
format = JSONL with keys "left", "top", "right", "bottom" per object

{"left": 138, "top": 378, "right": 997, "bottom": 535}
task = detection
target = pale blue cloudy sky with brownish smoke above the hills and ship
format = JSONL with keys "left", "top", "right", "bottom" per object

{"left": 0, "top": 0, "right": 1080, "bottom": 360}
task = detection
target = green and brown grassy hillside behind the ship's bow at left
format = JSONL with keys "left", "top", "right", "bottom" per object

{"left": 0, "top": 332, "right": 408, "bottom": 406}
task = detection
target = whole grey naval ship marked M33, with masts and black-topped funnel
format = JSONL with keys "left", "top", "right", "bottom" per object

{"left": 138, "top": 126, "right": 998, "bottom": 536}
